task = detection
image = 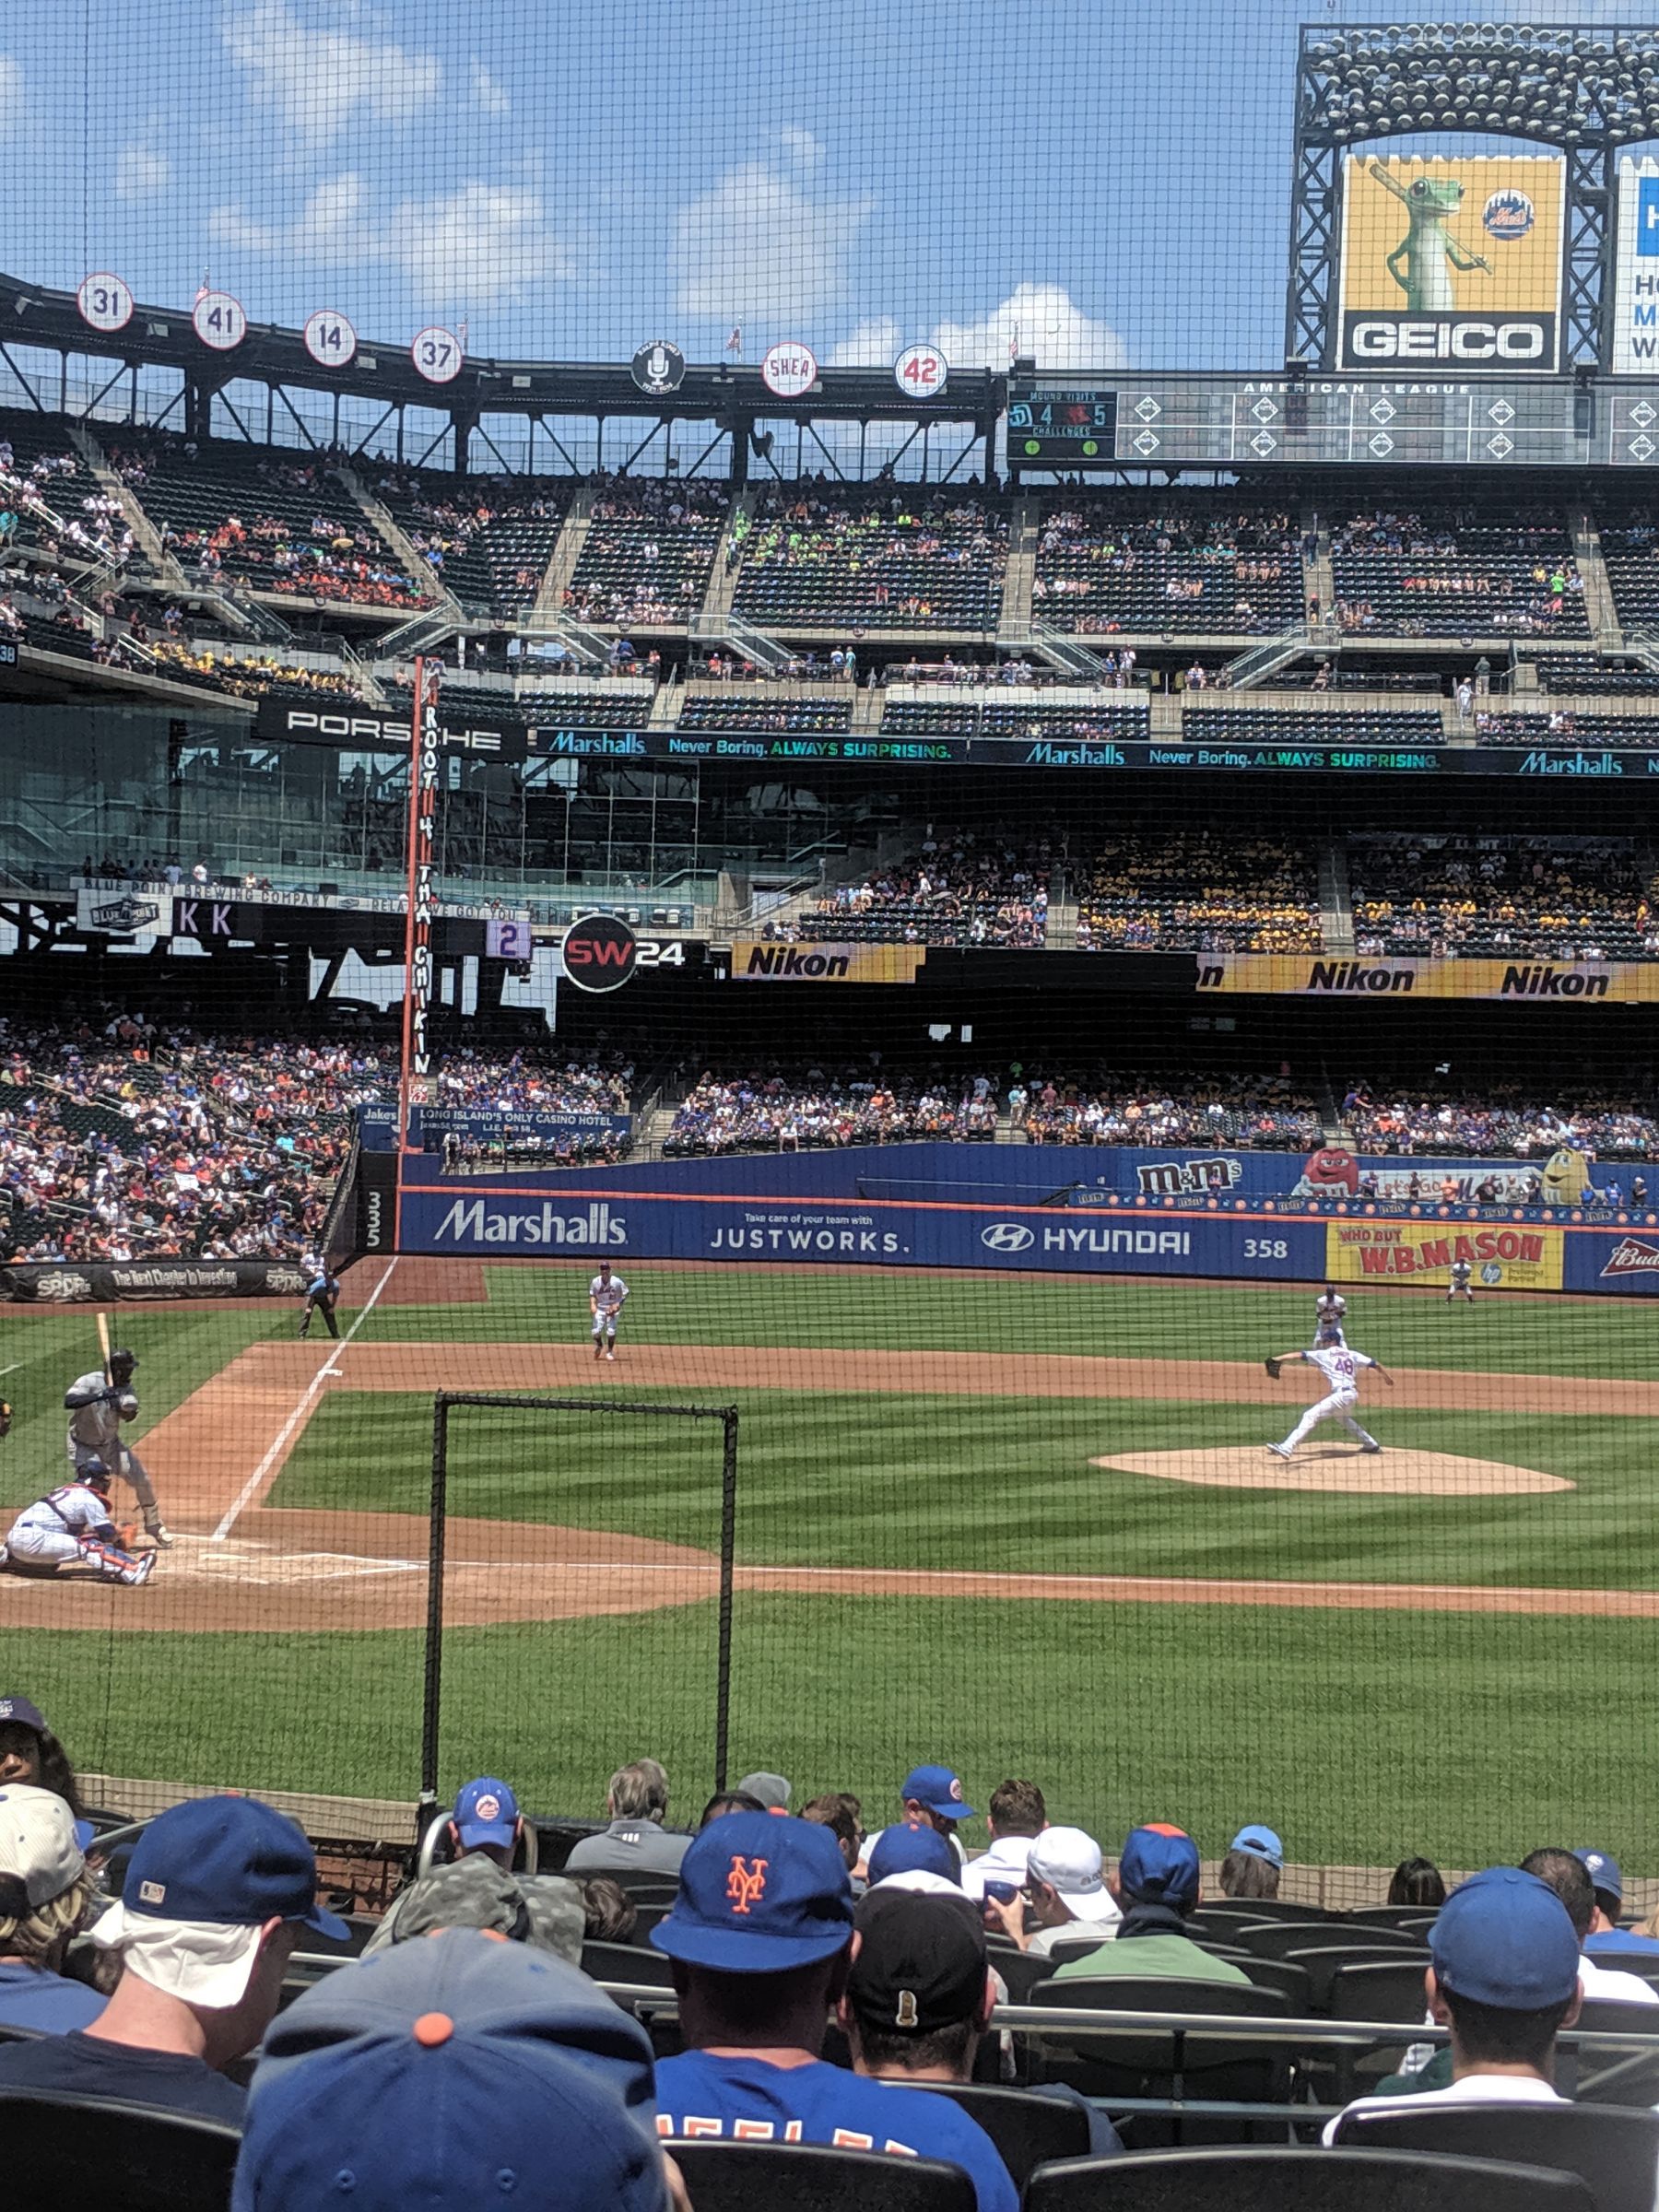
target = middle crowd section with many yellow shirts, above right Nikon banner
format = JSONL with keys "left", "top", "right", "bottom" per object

{"left": 1077, "top": 830, "right": 1323, "bottom": 953}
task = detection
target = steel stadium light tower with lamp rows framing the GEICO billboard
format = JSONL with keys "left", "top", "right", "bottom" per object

{"left": 1285, "top": 22, "right": 1659, "bottom": 367}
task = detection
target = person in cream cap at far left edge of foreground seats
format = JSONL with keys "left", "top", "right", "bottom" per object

{"left": 0, "top": 1783, "right": 104, "bottom": 2035}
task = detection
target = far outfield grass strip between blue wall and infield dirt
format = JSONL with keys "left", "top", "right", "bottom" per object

{"left": 365, "top": 1256, "right": 1654, "bottom": 1378}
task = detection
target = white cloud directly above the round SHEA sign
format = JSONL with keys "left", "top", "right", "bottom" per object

{"left": 673, "top": 151, "right": 876, "bottom": 323}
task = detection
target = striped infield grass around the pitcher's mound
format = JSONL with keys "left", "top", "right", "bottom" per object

{"left": 270, "top": 1382, "right": 1659, "bottom": 1591}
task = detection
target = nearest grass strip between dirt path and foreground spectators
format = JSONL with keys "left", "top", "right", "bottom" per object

{"left": 13, "top": 1597, "right": 1653, "bottom": 1874}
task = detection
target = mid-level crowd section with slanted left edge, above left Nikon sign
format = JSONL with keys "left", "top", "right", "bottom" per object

{"left": 800, "top": 828, "right": 1060, "bottom": 947}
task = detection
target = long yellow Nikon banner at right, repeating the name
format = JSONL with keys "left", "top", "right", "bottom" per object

{"left": 1196, "top": 953, "right": 1659, "bottom": 1006}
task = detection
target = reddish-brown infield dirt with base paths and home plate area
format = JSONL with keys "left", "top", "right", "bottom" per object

{"left": 19, "top": 1343, "right": 1659, "bottom": 1632}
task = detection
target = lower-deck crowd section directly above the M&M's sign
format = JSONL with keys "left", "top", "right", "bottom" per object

{"left": 1008, "top": 1068, "right": 1321, "bottom": 1152}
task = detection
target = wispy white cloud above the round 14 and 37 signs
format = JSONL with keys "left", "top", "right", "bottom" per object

{"left": 208, "top": 168, "right": 575, "bottom": 308}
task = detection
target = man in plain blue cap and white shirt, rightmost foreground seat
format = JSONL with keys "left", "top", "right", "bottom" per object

{"left": 1323, "top": 1867, "right": 1580, "bottom": 2144}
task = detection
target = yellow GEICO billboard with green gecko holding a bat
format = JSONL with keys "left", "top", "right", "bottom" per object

{"left": 1336, "top": 155, "right": 1564, "bottom": 374}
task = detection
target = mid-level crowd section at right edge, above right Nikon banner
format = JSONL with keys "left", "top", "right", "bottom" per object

{"left": 1347, "top": 831, "right": 1659, "bottom": 960}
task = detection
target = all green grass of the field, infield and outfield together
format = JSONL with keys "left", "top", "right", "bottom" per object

{"left": 0, "top": 1261, "right": 1659, "bottom": 1865}
